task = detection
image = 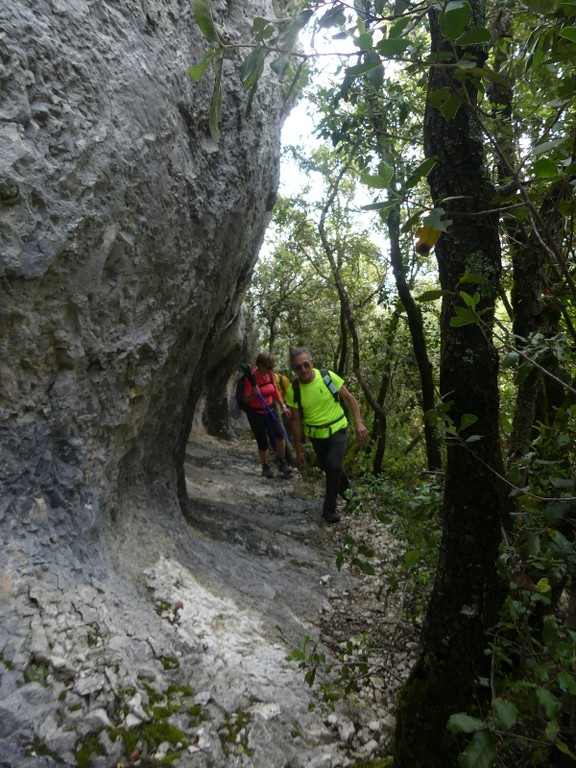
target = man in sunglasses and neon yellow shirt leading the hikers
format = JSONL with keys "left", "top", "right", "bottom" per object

{"left": 285, "top": 347, "right": 368, "bottom": 523}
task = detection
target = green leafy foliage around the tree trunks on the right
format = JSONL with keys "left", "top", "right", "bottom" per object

{"left": 190, "top": 0, "right": 576, "bottom": 766}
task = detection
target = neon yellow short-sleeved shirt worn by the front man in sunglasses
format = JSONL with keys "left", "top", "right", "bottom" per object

{"left": 285, "top": 368, "right": 348, "bottom": 439}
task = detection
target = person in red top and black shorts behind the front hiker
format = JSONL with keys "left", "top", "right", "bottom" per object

{"left": 243, "top": 352, "right": 291, "bottom": 478}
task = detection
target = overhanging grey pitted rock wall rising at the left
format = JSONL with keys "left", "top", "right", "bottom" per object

{"left": 0, "top": 0, "right": 281, "bottom": 562}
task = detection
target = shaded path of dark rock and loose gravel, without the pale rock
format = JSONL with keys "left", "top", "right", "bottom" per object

{"left": 187, "top": 436, "right": 419, "bottom": 762}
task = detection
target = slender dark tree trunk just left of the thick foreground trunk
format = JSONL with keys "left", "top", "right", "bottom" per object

{"left": 387, "top": 201, "right": 442, "bottom": 472}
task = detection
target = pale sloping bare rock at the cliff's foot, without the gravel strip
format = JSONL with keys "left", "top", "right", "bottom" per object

{"left": 0, "top": 435, "right": 364, "bottom": 768}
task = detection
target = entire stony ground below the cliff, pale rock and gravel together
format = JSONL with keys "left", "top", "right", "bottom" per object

{"left": 0, "top": 428, "right": 416, "bottom": 768}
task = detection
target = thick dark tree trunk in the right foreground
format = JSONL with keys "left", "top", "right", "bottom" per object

{"left": 394, "top": 0, "right": 506, "bottom": 768}
